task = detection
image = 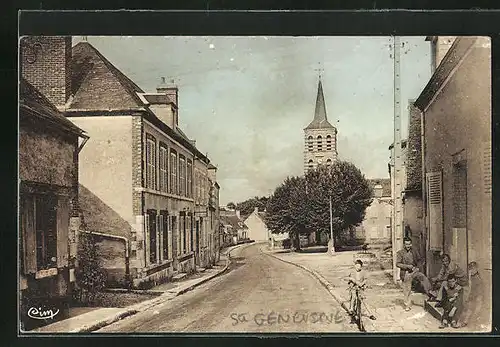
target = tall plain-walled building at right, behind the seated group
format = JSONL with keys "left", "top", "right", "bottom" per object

{"left": 415, "top": 37, "right": 492, "bottom": 328}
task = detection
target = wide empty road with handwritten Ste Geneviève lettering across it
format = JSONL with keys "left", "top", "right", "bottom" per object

{"left": 95, "top": 244, "right": 356, "bottom": 333}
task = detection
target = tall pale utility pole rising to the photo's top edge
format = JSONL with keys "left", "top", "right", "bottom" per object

{"left": 392, "top": 36, "right": 403, "bottom": 282}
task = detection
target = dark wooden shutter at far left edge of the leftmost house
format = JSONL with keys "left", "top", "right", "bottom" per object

{"left": 21, "top": 196, "right": 36, "bottom": 274}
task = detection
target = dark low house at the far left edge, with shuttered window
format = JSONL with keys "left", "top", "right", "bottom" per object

{"left": 19, "top": 77, "right": 88, "bottom": 330}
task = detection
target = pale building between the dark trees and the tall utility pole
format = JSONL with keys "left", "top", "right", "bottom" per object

{"left": 356, "top": 178, "right": 392, "bottom": 244}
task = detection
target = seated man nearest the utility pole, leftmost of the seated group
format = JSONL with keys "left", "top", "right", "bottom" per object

{"left": 396, "top": 238, "right": 431, "bottom": 311}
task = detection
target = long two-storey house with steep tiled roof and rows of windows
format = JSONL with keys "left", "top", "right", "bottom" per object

{"left": 21, "top": 37, "right": 221, "bottom": 287}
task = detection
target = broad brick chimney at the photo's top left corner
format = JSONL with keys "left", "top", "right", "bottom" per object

{"left": 19, "top": 36, "right": 71, "bottom": 109}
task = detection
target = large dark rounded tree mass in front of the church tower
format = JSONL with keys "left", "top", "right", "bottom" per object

{"left": 266, "top": 161, "right": 372, "bottom": 248}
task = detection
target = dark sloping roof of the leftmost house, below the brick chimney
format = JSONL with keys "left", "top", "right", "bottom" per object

{"left": 19, "top": 78, "right": 84, "bottom": 135}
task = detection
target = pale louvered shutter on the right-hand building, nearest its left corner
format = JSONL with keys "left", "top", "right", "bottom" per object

{"left": 426, "top": 171, "right": 443, "bottom": 251}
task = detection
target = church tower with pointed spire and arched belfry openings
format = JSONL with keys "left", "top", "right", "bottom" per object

{"left": 304, "top": 76, "right": 337, "bottom": 172}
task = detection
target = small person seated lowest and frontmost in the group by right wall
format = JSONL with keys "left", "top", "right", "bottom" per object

{"left": 439, "top": 274, "right": 464, "bottom": 329}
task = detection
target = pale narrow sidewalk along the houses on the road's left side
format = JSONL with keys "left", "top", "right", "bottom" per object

{"left": 29, "top": 245, "right": 245, "bottom": 334}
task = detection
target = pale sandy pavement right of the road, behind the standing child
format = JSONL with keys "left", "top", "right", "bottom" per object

{"left": 262, "top": 247, "right": 446, "bottom": 333}
